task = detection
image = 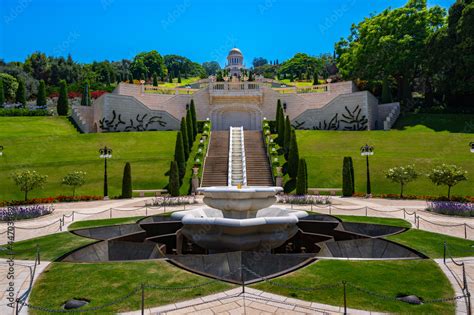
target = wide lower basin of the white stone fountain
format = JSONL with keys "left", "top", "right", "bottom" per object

{"left": 172, "top": 207, "right": 307, "bottom": 252}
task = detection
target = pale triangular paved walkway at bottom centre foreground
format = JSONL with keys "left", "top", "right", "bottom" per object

{"left": 121, "top": 288, "right": 384, "bottom": 315}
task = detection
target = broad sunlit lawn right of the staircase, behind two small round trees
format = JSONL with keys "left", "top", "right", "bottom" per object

{"left": 297, "top": 126, "right": 474, "bottom": 196}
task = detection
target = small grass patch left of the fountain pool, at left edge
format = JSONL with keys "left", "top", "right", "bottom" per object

{"left": 0, "top": 232, "right": 95, "bottom": 261}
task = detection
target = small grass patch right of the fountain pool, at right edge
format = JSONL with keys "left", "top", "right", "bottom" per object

{"left": 387, "top": 229, "right": 474, "bottom": 258}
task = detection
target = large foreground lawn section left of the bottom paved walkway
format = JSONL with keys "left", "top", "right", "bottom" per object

{"left": 30, "top": 261, "right": 232, "bottom": 314}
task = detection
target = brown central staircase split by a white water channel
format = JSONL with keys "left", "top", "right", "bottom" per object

{"left": 201, "top": 128, "right": 274, "bottom": 187}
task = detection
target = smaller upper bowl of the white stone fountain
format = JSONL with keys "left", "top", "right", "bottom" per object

{"left": 198, "top": 186, "right": 283, "bottom": 219}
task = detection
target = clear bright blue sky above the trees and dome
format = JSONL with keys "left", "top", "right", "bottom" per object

{"left": 0, "top": 0, "right": 454, "bottom": 65}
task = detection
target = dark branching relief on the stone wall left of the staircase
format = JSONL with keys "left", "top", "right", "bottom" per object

{"left": 99, "top": 110, "right": 167, "bottom": 132}
